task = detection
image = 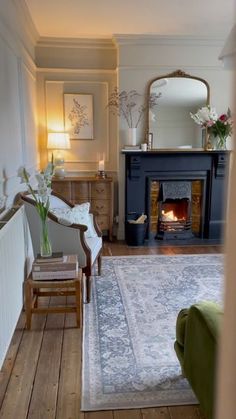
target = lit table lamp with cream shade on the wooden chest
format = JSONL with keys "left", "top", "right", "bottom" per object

{"left": 47, "top": 132, "right": 70, "bottom": 178}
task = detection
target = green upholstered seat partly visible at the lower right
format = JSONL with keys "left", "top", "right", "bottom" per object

{"left": 174, "top": 302, "right": 223, "bottom": 419}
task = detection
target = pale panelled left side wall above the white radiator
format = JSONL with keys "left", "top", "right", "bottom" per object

{"left": 0, "top": 0, "right": 38, "bottom": 210}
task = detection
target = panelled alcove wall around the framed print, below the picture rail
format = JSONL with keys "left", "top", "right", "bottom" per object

{"left": 37, "top": 69, "right": 117, "bottom": 175}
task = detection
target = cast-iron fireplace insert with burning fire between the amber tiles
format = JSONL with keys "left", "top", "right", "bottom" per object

{"left": 156, "top": 181, "right": 193, "bottom": 240}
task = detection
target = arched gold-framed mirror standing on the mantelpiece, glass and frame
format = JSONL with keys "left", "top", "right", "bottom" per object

{"left": 148, "top": 70, "right": 210, "bottom": 149}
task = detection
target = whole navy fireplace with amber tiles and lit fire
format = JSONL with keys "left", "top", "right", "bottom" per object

{"left": 123, "top": 149, "right": 230, "bottom": 242}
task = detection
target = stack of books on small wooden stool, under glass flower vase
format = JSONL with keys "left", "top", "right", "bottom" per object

{"left": 32, "top": 254, "right": 78, "bottom": 281}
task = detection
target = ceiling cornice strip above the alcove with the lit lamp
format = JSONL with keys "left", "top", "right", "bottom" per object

{"left": 37, "top": 36, "right": 116, "bottom": 49}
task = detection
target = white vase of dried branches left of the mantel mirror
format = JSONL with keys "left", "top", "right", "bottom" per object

{"left": 107, "top": 87, "right": 161, "bottom": 146}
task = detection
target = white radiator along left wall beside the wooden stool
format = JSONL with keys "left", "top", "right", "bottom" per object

{"left": 0, "top": 207, "right": 32, "bottom": 368}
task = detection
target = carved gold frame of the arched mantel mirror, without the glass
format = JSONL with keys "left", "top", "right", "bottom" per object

{"left": 147, "top": 70, "right": 210, "bottom": 150}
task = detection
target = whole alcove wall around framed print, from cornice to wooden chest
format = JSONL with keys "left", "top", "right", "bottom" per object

{"left": 36, "top": 38, "right": 118, "bottom": 175}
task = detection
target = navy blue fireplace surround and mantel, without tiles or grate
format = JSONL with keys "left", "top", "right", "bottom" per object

{"left": 122, "top": 150, "right": 230, "bottom": 241}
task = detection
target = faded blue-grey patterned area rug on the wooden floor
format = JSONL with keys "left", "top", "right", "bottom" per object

{"left": 82, "top": 255, "right": 223, "bottom": 411}
